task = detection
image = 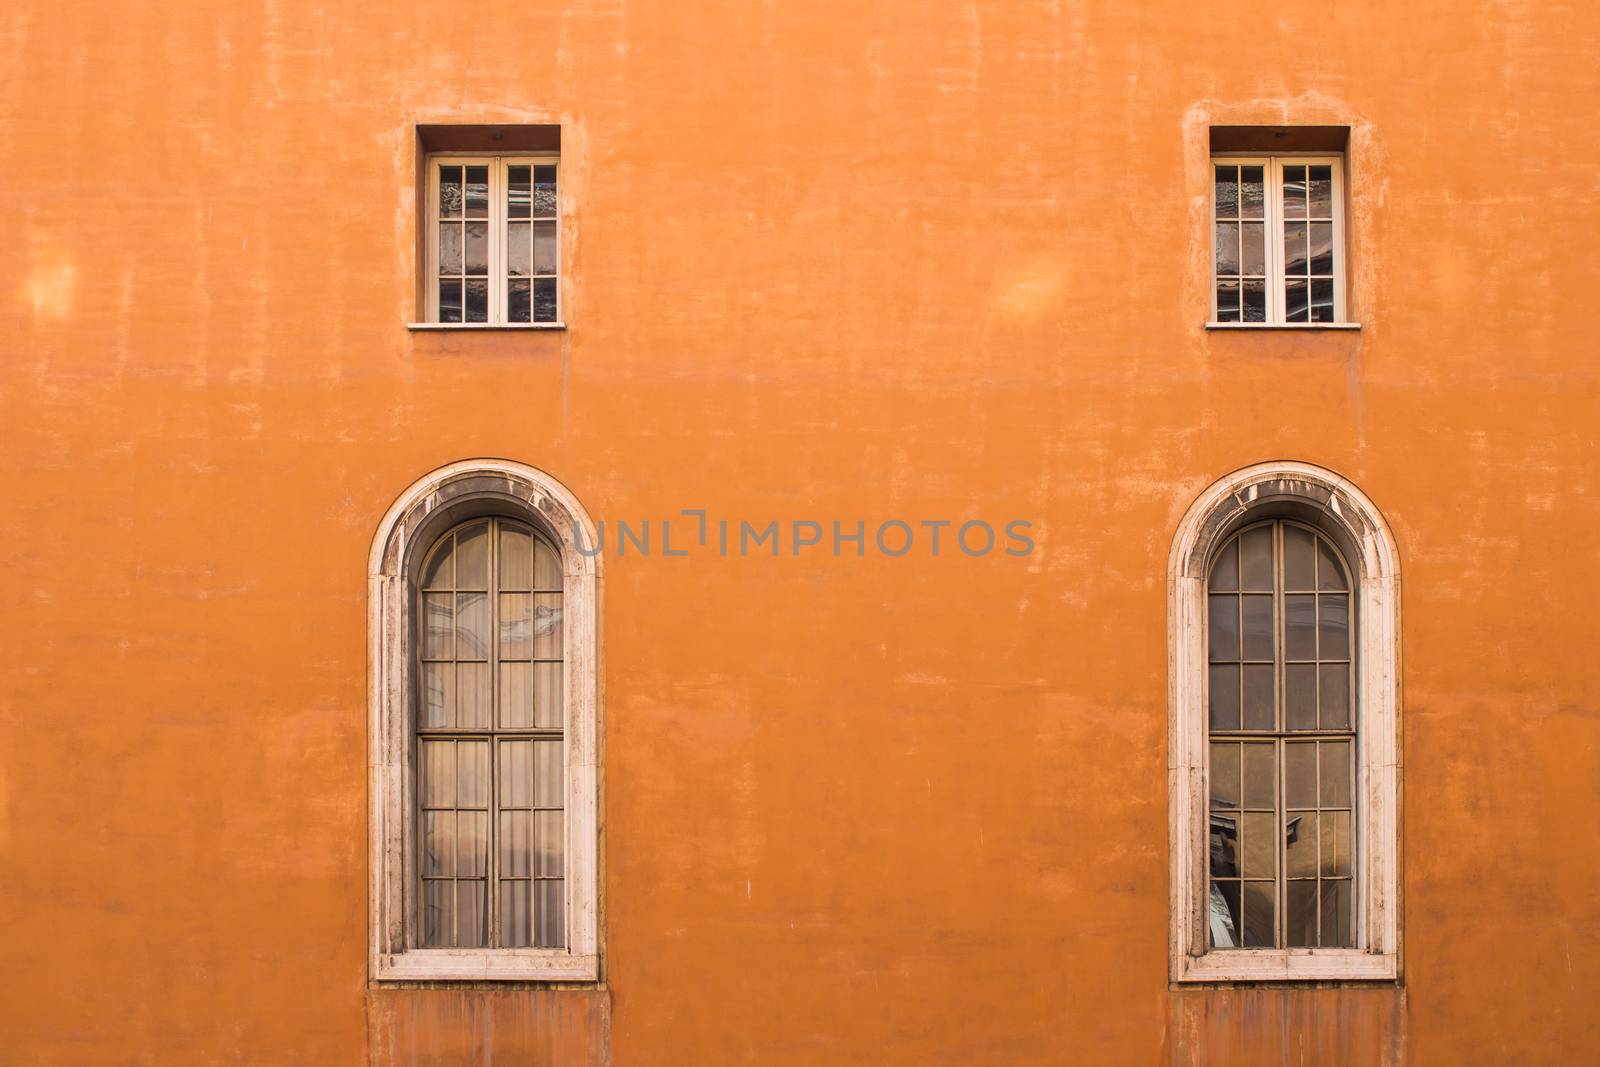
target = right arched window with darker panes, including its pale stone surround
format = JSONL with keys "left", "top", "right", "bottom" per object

{"left": 1171, "top": 464, "right": 1398, "bottom": 981}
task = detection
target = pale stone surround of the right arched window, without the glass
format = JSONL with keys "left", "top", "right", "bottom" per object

{"left": 1166, "top": 462, "right": 1402, "bottom": 982}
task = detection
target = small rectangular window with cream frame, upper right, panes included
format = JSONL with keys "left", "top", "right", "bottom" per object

{"left": 1211, "top": 155, "right": 1347, "bottom": 325}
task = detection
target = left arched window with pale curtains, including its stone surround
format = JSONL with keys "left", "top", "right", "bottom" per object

{"left": 371, "top": 461, "right": 600, "bottom": 981}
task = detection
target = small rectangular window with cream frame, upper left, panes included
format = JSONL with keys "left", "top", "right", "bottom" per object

{"left": 424, "top": 155, "right": 562, "bottom": 326}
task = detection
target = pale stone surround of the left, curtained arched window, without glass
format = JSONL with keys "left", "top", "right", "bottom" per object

{"left": 368, "top": 459, "right": 602, "bottom": 982}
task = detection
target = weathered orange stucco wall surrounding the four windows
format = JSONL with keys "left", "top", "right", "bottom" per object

{"left": 0, "top": 0, "right": 1600, "bottom": 1065}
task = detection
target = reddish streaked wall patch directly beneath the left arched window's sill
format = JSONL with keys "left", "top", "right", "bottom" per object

{"left": 366, "top": 989, "right": 611, "bottom": 1067}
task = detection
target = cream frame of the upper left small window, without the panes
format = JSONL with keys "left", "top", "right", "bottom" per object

{"left": 413, "top": 152, "right": 566, "bottom": 330}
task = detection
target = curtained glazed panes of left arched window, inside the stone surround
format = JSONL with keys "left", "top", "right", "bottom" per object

{"left": 414, "top": 518, "right": 566, "bottom": 949}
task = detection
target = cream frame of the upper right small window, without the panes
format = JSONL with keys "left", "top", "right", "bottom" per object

{"left": 1206, "top": 152, "right": 1355, "bottom": 330}
